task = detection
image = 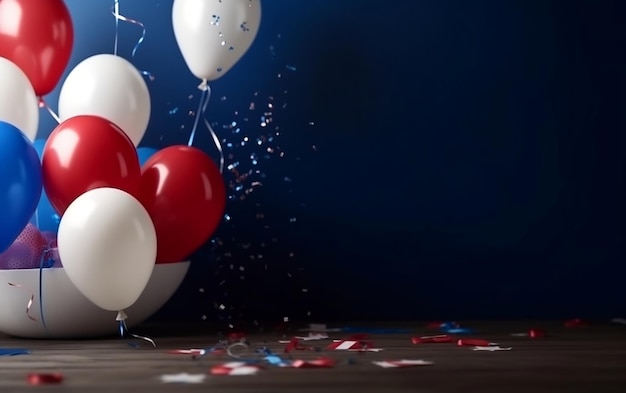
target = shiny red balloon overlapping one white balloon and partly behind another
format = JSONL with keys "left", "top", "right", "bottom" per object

{"left": 41, "top": 115, "right": 141, "bottom": 215}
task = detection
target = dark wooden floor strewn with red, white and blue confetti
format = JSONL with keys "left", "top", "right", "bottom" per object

{"left": 0, "top": 322, "right": 626, "bottom": 393}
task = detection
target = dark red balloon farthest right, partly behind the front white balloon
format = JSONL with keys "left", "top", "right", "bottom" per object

{"left": 140, "top": 146, "right": 226, "bottom": 263}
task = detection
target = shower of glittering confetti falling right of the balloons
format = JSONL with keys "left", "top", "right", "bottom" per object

{"left": 167, "top": 31, "right": 314, "bottom": 330}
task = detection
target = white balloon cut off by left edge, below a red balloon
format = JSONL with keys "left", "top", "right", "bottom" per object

{"left": 0, "top": 57, "right": 39, "bottom": 142}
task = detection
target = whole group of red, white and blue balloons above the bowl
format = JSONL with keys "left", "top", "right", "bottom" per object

{"left": 0, "top": 0, "right": 261, "bottom": 311}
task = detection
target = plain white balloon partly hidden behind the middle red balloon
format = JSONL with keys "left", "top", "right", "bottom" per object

{"left": 59, "top": 54, "right": 151, "bottom": 146}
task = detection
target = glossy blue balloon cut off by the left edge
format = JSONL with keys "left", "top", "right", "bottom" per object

{"left": 0, "top": 121, "right": 42, "bottom": 252}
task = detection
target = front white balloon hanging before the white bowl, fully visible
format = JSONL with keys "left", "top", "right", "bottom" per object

{"left": 57, "top": 187, "right": 157, "bottom": 311}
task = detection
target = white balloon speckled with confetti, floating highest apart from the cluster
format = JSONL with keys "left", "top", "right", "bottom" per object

{"left": 172, "top": 0, "right": 261, "bottom": 81}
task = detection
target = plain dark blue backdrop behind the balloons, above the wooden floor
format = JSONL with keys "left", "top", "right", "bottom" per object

{"left": 40, "top": 0, "right": 626, "bottom": 320}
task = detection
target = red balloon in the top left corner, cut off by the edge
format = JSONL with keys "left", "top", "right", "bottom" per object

{"left": 0, "top": 0, "right": 74, "bottom": 96}
